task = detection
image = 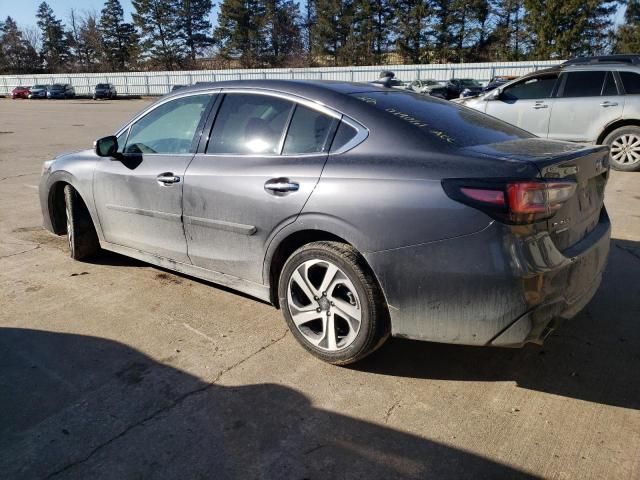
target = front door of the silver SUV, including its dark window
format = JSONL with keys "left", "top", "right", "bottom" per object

{"left": 485, "top": 73, "right": 558, "bottom": 138}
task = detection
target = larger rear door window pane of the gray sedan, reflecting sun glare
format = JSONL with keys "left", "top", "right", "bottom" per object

{"left": 207, "top": 94, "right": 293, "bottom": 154}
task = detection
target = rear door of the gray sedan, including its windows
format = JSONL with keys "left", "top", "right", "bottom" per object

{"left": 184, "top": 91, "right": 337, "bottom": 283}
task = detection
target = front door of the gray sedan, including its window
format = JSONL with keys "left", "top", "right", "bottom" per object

{"left": 93, "top": 94, "right": 212, "bottom": 263}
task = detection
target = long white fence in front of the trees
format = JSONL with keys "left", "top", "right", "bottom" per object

{"left": 0, "top": 60, "right": 561, "bottom": 95}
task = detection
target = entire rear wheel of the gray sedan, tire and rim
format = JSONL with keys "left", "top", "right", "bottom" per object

{"left": 278, "top": 242, "right": 389, "bottom": 365}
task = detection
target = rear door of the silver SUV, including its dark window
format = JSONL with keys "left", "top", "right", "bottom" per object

{"left": 549, "top": 70, "right": 624, "bottom": 142}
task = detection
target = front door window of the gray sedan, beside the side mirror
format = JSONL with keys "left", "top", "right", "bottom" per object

{"left": 125, "top": 95, "right": 211, "bottom": 154}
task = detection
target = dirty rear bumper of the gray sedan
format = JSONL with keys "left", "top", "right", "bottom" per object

{"left": 365, "top": 208, "right": 611, "bottom": 346}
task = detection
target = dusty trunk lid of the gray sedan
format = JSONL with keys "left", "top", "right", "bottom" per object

{"left": 468, "top": 138, "right": 609, "bottom": 251}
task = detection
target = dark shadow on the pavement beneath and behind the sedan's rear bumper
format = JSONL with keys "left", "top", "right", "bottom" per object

{"left": 352, "top": 239, "right": 640, "bottom": 410}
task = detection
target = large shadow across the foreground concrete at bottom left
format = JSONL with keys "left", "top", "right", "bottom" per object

{"left": 0, "top": 328, "right": 532, "bottom": 479}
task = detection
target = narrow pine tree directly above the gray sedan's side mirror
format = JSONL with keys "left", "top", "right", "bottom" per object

{"left": 98, "top": 0, "right": 139, "bottom": 71}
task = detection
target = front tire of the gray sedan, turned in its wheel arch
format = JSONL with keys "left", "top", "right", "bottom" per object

{"left": 64, "top": 185, "right": 100, "bottom": 260}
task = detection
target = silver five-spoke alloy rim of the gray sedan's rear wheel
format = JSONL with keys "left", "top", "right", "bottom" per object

{"left": 287, "top": 259, "right": 362, "bottom": 352}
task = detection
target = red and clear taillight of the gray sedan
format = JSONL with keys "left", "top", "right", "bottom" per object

{"left": 442, "top": 179, "right": 576, "bottom": 224}
